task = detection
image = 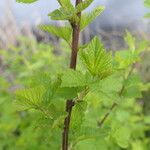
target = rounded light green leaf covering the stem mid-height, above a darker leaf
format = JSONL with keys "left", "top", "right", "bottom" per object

{"left": 61, "top": 69, "right": 87, "bottom": 87}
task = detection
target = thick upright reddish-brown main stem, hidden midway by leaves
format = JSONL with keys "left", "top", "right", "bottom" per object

{"left": 62, "top": 0, "right": 82, "bottom": 150}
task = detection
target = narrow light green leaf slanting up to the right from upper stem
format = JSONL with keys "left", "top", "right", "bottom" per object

{"left": 80, "top": 6, "right": 105, "bottom": 31}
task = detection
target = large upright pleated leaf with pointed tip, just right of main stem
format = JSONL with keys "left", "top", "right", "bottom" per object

{"left": 80, "top": 37, "right": 112, "bottom": 78}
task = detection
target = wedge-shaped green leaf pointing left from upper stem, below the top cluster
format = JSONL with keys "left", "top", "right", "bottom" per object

{"left": 39, "top": 25, "right": 72, "bottom": 43}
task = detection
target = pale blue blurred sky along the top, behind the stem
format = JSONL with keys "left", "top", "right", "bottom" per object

{"left": 0, "top": 0, "right": 146, "bottom": 24}
